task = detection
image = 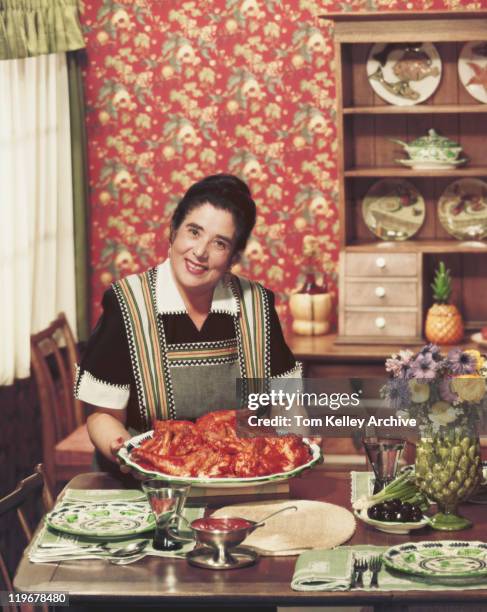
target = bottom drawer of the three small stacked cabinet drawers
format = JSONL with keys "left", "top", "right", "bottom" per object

{"left": 345, "top": 310, "right": 417, "bottom": 338}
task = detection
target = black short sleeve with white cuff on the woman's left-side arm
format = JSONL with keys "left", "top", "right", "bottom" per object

{"left": 75, "top": 289, "right": 133, "bottom": 409}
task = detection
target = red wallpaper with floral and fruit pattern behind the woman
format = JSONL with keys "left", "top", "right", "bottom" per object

{"left": 82, "top": 0, "right": 479, "bottom": 322}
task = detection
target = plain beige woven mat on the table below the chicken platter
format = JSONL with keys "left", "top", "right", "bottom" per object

{"left": 212, "top": 500, "right": 355, "bottom": 556}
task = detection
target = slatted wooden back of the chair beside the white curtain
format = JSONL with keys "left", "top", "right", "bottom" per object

{"left": 31, "top": 313, "right": 85, "bottom": 485}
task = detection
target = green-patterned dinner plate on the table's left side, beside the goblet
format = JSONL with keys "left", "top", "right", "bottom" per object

{"left": 46, "top": 502, "right": 155, "bottom": 538}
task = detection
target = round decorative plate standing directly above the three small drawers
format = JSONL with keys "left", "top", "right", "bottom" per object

{"left": 362, "top": 179, "right": 426, "bottom": 240}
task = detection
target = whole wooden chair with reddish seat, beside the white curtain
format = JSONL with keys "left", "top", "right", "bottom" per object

{"left": 30, "top": 313, "right": 94, "bottom": 490}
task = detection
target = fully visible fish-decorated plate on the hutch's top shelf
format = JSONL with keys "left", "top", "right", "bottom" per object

{"left": 366, "top": 43, "right": 441, "bottom": 106}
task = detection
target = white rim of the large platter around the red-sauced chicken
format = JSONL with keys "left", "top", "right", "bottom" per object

{"left": 118, "top": 431, "right": 322, "bottom": 488}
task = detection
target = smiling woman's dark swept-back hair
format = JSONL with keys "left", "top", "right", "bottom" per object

{"left": 171, "top": 174, "right": 256, "bottom": 252}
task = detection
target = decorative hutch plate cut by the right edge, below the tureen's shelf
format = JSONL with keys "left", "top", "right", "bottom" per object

{"left": 438, "top": 178, "right": 487, "bottom": 240}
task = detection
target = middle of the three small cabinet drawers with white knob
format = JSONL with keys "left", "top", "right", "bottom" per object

{"left": 345, "top": 278, "right": 418, "bottom": 307}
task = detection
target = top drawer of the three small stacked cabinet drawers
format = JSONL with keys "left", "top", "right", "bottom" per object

{"left": 345, "top": 252, "right": 418, "bottom": 276}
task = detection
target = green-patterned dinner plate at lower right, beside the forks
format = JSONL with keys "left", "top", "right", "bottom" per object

{"left": 382, "top": 540, "right": 487, "bottom": 584}
